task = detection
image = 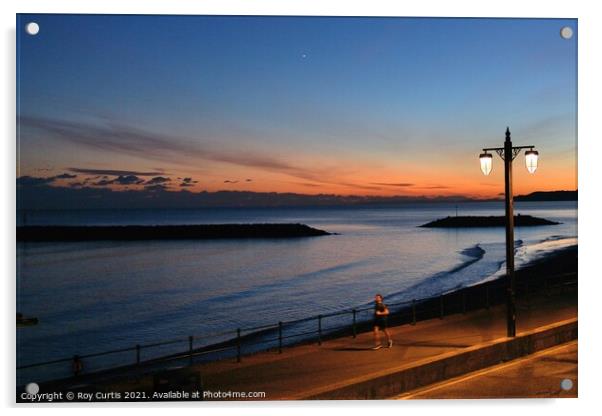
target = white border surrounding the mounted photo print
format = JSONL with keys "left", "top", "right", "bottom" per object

{"left": 0, "top": 0, "right": 602, "bottom": 416}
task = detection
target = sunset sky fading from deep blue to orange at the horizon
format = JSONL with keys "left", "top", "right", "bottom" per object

{"left": 17, "top": 15, "right": 577, "bottom": 198}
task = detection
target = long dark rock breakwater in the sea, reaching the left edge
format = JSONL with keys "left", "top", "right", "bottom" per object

{"left": 17, "top": 224, "right": 331, "bottom": 242}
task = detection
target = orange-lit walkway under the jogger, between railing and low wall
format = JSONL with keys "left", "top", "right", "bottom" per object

{"left": 191, "top": 293, "right": 577, "bottom": 400}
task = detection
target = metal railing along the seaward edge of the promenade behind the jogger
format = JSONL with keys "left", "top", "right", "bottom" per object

{"left": 17, "top": 273, "right": 576, "bottom": 381}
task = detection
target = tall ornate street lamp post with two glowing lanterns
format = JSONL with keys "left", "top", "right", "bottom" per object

{"left": 479, "top": 128, "right": 539, "bottom": 337}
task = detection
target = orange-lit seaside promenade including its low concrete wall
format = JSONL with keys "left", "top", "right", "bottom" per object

{"left": 30, "top": 286, "right": 577, "bottom": 401}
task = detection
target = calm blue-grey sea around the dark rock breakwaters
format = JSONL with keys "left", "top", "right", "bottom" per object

{"left": 17, "top": 202, "right": 577, "bottom": 384}
